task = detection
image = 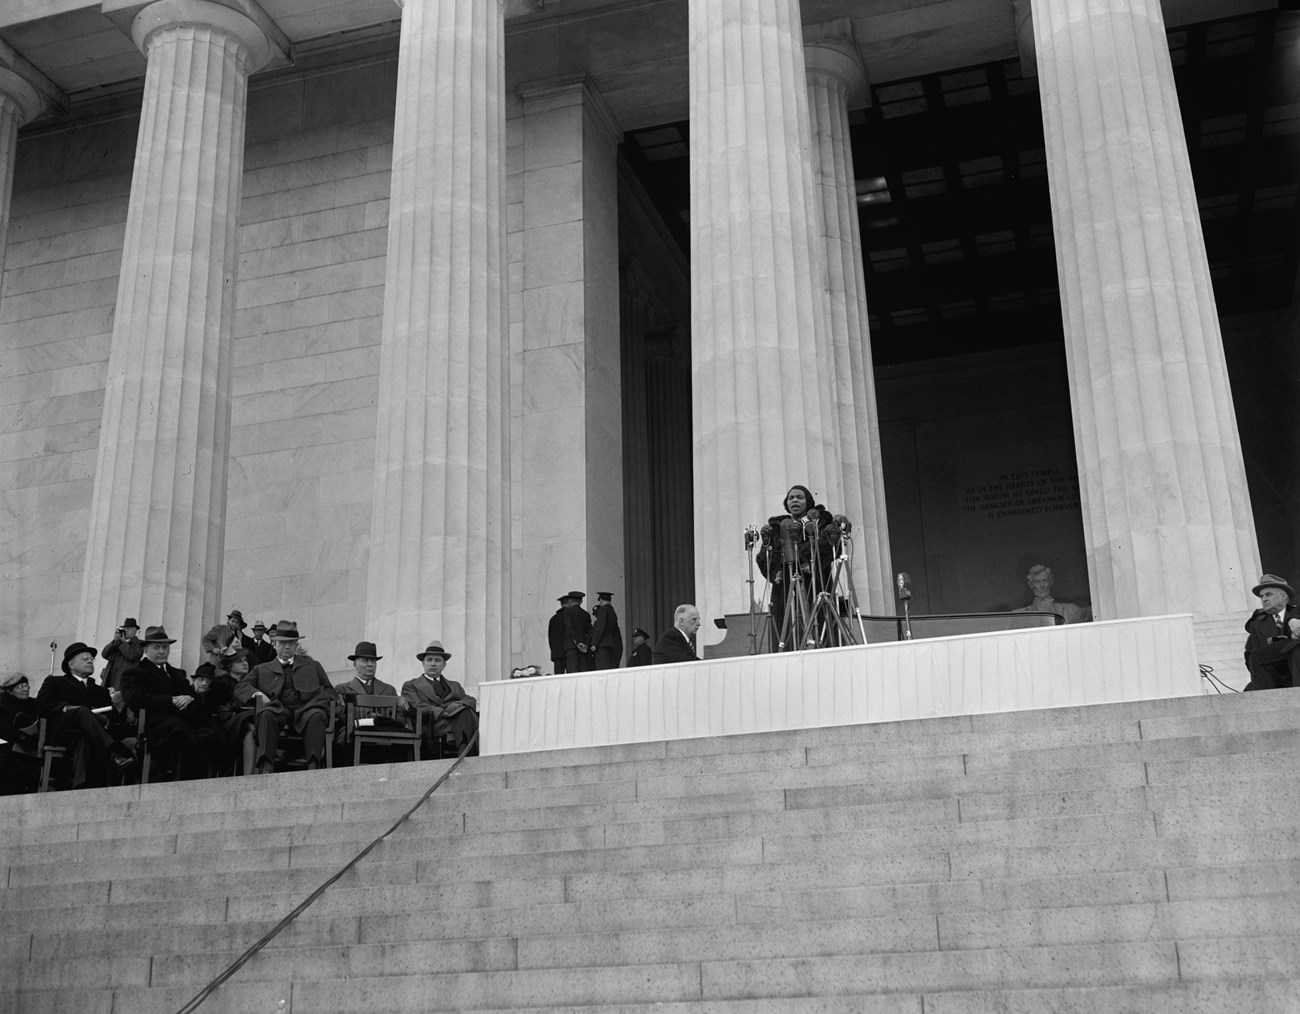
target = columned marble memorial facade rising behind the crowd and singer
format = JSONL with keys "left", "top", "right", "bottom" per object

{"left": 0, "top": 0, "right": 1300, "bottom": 686}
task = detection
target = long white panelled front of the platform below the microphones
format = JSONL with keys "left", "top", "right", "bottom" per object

{"left": 477, "top": 616, "right": 1201, "bottom": 754}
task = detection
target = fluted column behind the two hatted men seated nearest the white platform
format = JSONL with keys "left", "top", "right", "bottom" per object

{"left": 365, "top": 0, "right": 511, "bottom": 685}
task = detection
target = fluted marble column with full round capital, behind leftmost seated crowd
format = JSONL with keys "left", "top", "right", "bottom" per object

{"left": 69, "top": 0, "right": 270, "bottom": 664}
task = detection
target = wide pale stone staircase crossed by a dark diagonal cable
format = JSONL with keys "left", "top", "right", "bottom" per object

{"left": 0, "top": 690, "right": 1300, "bottom": 1014}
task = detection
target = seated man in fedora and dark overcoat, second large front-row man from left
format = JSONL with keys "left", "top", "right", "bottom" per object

{"left": 122, "top": 625, "right": 217, "bottom": 779}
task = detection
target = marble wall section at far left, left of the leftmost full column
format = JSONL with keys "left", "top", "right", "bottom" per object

{"left": 0, "top": 116, "right": 139, "bottom": 691}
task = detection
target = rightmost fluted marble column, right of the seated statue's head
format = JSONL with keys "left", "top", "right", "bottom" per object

{"left": 1032, "top": 0, "right": 1260, "bottom": 619}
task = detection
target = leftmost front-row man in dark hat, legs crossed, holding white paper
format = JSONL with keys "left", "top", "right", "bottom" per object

{"left": 36, "top": 641, "right": 135, "bottom": 789}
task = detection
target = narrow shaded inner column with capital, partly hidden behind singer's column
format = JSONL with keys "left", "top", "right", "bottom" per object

{"left": 803, "top": 27, "right": 894, "bottom": 615}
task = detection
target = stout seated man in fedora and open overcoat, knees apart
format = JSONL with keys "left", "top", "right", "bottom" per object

{"left": 235, "top": 620, "right": 338, "bottom": 775}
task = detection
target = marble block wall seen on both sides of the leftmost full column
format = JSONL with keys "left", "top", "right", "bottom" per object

{"left": 0, "top": 52, "right": 400, "bottom": 675}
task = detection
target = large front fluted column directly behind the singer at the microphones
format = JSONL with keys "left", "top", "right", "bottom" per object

{"left": 689, "top": 0, "right": 842, "bottom": 644}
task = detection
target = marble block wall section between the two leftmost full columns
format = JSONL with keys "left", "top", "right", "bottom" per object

{"left": 222, "top": 55, "right": 395, "bottom": 677}
